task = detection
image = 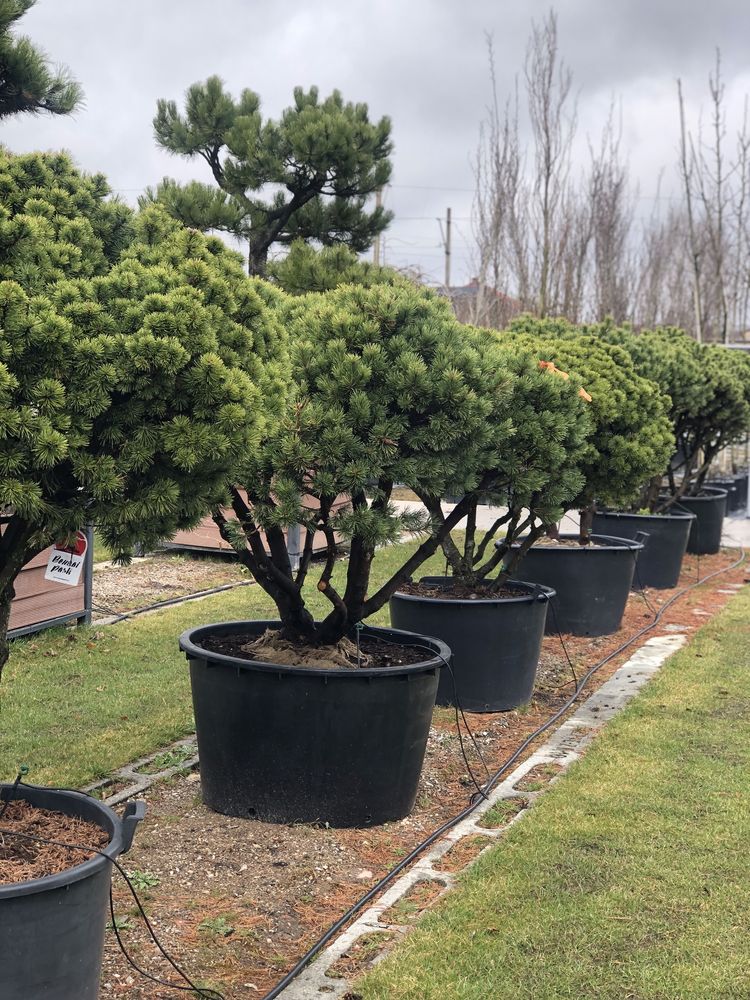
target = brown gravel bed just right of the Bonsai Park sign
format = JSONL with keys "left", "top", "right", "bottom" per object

{"left": 93, "top": 552, "right": 249, "bottom": 618}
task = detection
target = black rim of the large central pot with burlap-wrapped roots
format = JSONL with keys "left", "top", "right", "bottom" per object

{"left": 179, "top": 619, "right": 452, "bottom": 679}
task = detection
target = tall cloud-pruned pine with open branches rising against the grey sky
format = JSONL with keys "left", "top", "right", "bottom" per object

{"left": 143, "top": 76, "right": 392, "bottom": 275}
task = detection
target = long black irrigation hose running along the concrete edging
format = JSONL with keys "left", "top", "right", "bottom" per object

{"left": 262, "top": 549, "right": 745, "bottom": 1000}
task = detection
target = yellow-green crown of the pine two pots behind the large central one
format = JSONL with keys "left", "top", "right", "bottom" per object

{"left": 506, "top": 316, "right": 674, "bottom": 537}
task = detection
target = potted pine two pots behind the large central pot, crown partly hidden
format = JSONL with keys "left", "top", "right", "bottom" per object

{"left": 499, "top": 317, "right": 674, "bottom": 635}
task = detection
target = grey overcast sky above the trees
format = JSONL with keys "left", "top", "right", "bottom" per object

{"left": 0, "top": 0, "right": 750, "bottom": 284}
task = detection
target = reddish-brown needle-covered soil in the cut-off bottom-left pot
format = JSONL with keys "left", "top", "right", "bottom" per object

{"left": 0, "top": 799, "right": 109, "bottom": 885}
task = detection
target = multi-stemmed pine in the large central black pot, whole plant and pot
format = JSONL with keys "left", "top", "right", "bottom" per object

{"left": 181, "top": 282, "right": 520, "bottom": 825}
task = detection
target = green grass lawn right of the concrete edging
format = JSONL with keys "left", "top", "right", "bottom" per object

{"left": 355, "top": 589, "right": 750, "bottom": 1000}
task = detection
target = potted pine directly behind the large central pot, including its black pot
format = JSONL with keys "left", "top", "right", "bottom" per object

{"left": 391, "top": 330, "right": 592, "bottom": 712}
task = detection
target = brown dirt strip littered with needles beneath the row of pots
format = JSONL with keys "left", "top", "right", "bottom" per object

{"left": 101, "top": 552, "right": 747, "bottom": 1000}
